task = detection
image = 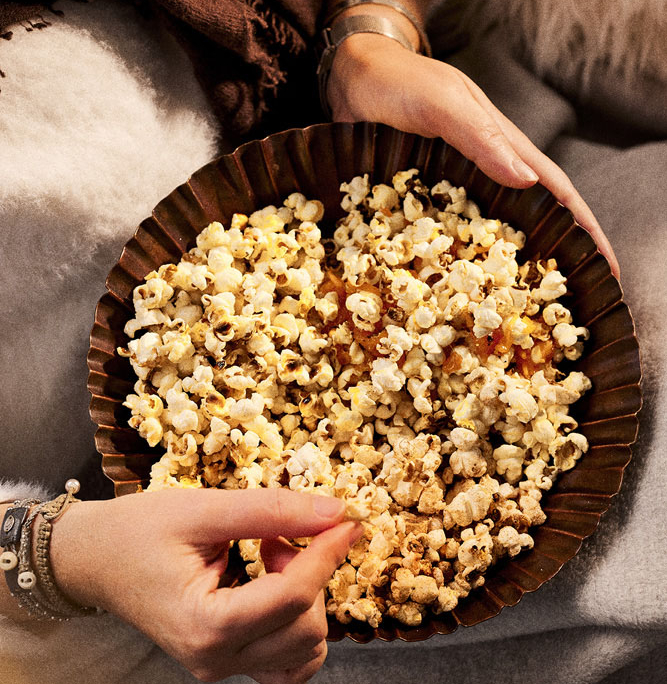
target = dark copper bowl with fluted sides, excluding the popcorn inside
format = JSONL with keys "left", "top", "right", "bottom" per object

{"left": 88, "top": 123, "right": 641, "bottom": 643}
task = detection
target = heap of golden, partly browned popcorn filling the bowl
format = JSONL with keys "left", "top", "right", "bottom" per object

{"left": 119, "top": 169, "right": 591, "bottom": 627}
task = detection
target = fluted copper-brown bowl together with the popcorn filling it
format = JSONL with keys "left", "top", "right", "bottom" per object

{"left": 88, "top": 123, "right": 641, "bottom": 642}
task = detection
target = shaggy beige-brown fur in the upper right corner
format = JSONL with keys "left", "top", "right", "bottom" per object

{"left": 432, "top": 0, "right": 667, "bottom": 137}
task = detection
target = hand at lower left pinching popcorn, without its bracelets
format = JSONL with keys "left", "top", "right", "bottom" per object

{"left": 51, "top": 489, "right": 361, "bottom": 684}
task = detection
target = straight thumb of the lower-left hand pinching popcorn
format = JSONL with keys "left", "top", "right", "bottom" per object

{"left": 188, "top": 488, "right": 345, "bottom": 543}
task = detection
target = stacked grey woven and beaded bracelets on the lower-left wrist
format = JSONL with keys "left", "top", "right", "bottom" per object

{"left": 0, "top": 479, "right": 100, "bottom": 620}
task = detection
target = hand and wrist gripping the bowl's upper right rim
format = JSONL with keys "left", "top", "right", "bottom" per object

{"left": 328, "top": 0, "right": 619, "bottom": 277}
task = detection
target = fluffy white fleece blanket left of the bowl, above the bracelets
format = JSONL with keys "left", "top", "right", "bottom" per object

{"left": 0, "top": 1, "right": 220, "bottom": 489}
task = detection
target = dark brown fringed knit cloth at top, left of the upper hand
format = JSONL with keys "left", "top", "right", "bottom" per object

{"left": 0, "top": 0, "right": 322, "bottom": 137}
